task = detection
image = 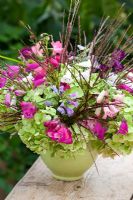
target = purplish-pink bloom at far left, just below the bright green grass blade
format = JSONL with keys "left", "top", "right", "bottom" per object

{"left": 6, "top": 65, "right": 20, "bottom": 79}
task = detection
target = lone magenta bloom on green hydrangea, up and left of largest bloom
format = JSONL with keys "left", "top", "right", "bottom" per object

{"left": 20, "top": 101, "right": 37, "bottom": 119}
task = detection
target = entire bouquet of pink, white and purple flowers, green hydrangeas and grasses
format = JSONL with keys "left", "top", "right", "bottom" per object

{"left": 0, "top": 1, "right": 133, "bottom": 157}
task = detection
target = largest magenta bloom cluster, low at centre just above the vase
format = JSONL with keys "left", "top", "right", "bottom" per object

{"left": 44, "top": 120, "right": 73, "bottom": 144}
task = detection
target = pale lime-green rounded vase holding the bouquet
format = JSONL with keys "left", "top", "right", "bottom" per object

{"left": 41, "top": 149, "right": 97, "bottom": 181}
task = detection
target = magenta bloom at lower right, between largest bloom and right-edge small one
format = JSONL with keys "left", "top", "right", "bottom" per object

{"left": 94, "top": 122, "right": 107, "bottom": 140}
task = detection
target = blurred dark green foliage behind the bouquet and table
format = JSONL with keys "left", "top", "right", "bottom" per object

{"left": 0, "top": 0, "right": 133, "bottom": 200}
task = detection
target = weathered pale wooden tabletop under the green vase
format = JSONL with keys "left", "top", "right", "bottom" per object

{"left": 6, "top": 154, "right": 133, "bottom": 200}
